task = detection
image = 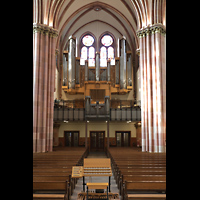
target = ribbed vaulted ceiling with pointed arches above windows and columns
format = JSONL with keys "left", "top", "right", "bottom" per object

{"left": 33, "top": 0, "right": 166, "bottom": 54}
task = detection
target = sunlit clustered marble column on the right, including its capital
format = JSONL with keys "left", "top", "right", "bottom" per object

{"left": 137, "top": 24, "right": 166, "bottom": 152}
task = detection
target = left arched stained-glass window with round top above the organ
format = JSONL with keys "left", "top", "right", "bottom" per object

{"left": 80, "top": 34, "right": 95, "bottom": 67}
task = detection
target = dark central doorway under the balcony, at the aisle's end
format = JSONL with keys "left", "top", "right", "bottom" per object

{"left": 90, "top": 131, "right": 105, "bottom": 151}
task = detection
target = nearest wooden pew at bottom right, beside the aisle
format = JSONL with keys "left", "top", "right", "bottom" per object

{"left": 123, "top": 181, "right": 166, "bottom": 200}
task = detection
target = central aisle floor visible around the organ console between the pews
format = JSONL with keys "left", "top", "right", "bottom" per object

{"left": 71, "top": 152, "right": 122, "bottom": 200}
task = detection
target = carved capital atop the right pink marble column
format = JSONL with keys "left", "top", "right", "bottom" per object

{"left": 137, "top": 23, "right": 166, "bottom": 38}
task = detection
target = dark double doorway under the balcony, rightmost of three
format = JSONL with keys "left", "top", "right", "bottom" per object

{"left": 115, "top": 131, "right": 131, "bottom": 147}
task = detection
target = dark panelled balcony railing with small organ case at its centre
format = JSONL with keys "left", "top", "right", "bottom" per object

{"left": 54, "top": 99, "right": 141, "bottom": 121}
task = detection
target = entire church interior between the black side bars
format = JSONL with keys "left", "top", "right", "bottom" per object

{"left": 33, "top": 0, "right": 166, "bottom": 200}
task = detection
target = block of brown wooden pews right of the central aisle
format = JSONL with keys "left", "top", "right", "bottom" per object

{"left": 107, "top": 148, "right": 166, "bottom": 200}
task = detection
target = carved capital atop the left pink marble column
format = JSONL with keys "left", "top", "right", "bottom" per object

{"left": 33, "top": 23, "right": 58, "bottom": 37}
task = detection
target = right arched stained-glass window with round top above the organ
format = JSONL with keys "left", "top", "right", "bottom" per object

{"left": 100, "top": 34, "right": 115, "bottom": 67}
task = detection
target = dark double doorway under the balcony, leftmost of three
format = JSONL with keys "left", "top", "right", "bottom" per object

{"left": 64, "top": 131, "right": 79, "bottom": 147}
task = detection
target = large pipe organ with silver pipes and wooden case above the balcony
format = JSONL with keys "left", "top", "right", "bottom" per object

{"left": 62, "top": 36, "right": 133, "bottom": 97}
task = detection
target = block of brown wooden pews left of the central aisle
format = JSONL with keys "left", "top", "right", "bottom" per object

{"left": 33, "top": 148, "right": 88, "bottom": 200}
